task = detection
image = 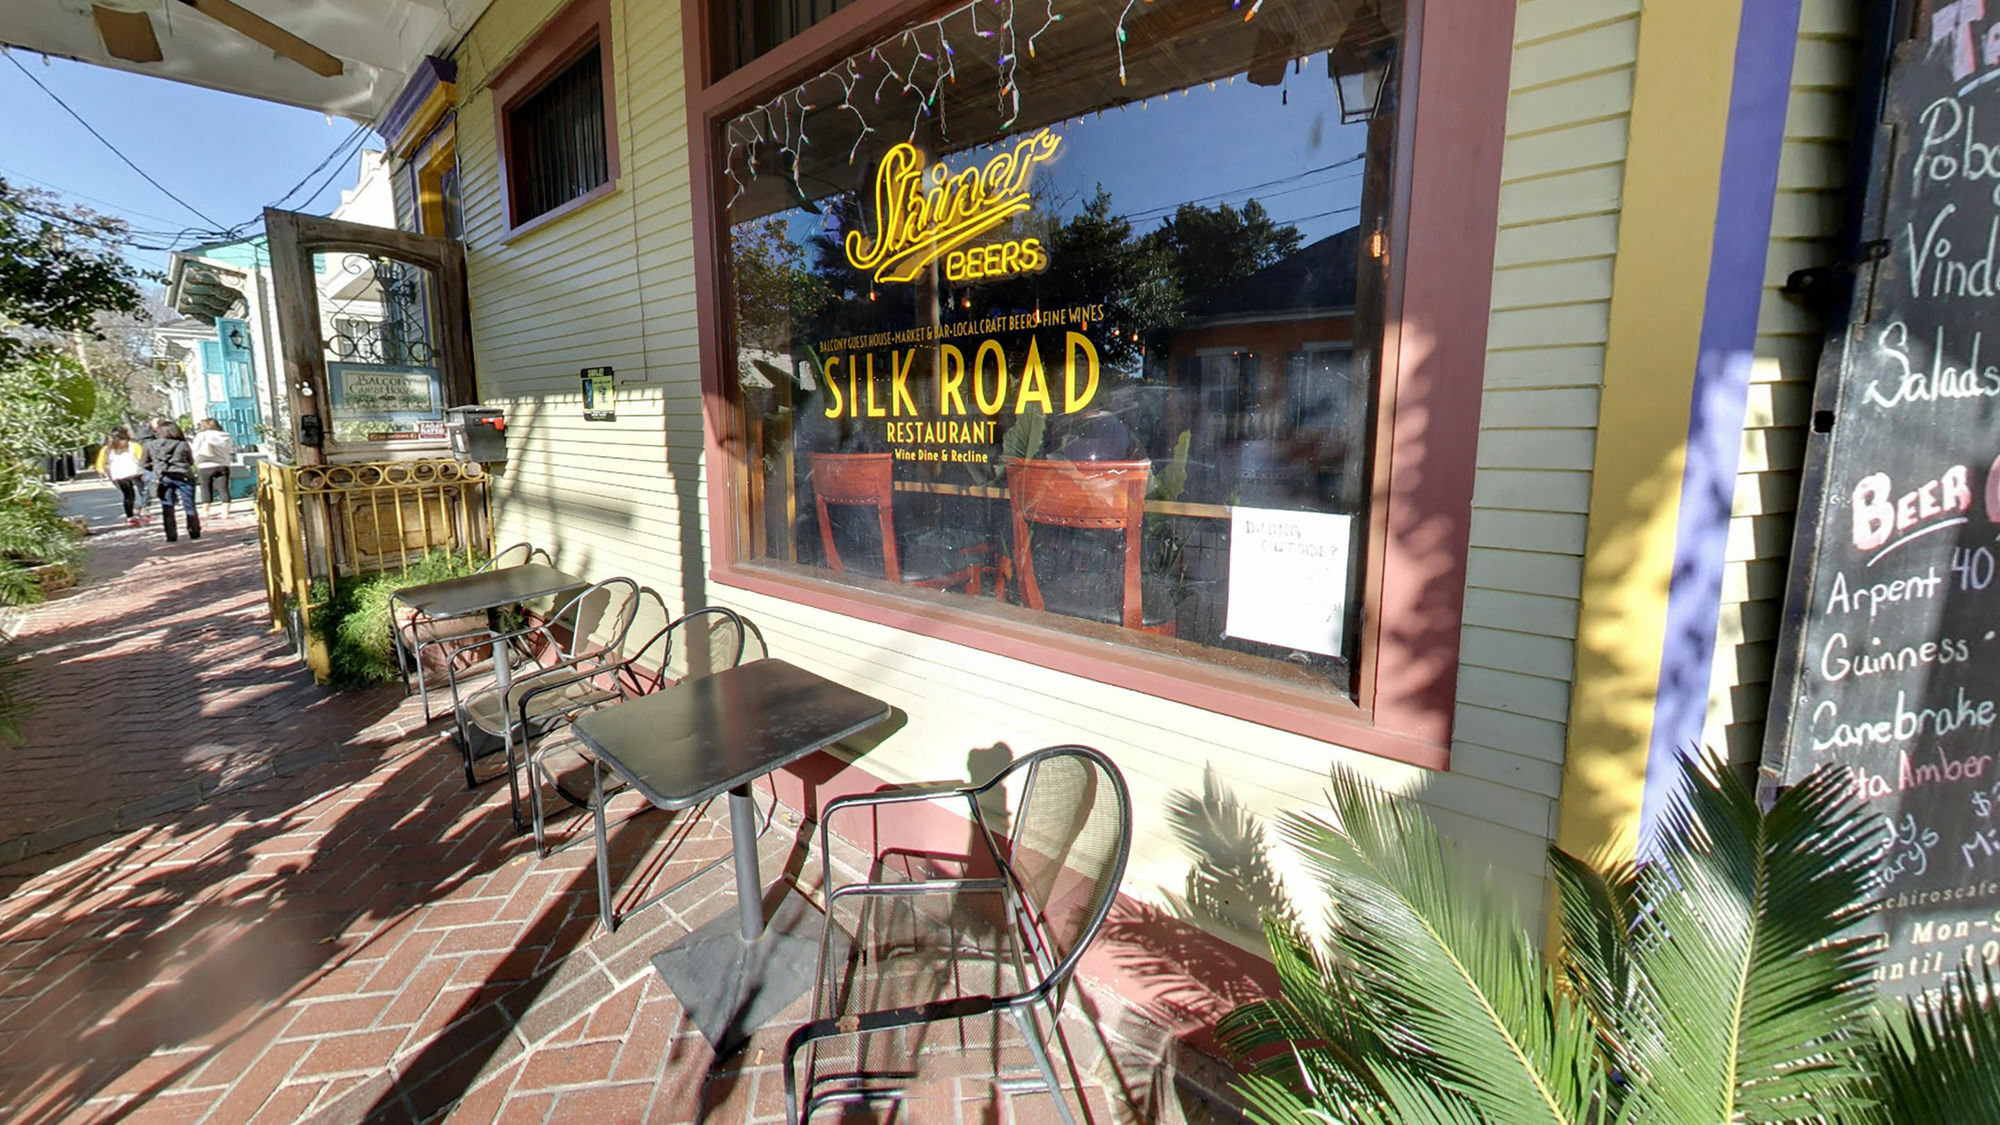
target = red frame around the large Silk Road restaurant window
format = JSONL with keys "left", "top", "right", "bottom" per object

{"left": 682, "top": 0, "right": 1514, "bottom": 769}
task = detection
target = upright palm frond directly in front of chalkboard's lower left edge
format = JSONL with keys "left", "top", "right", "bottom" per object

{"left": 1624, "top": 761, "right": 1878, "bottom": 1125}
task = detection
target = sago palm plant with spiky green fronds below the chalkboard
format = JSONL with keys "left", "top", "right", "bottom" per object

{"left": 1222, "top": 752, "right": 2000, "bottom": 1125}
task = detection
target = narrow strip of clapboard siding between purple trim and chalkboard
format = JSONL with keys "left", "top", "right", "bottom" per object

{"left": 1702, "top": 0, "right": 1862, "bottom": 765}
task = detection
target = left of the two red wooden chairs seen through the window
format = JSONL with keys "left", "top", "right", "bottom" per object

{"left": 808, "top": 452, "right": 992, "bottom": 595}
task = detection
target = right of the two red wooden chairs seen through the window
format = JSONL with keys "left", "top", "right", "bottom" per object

{"left": 1006, "top": 456, "right": 1174, "bottom": 637}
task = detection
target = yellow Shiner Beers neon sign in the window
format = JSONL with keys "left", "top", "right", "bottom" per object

{"left": 846, "top": 128, "right": 1062, "bottom": 282}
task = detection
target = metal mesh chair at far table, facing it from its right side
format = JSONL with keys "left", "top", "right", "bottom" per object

{"left": 446, "top": 579, "right": 660, "bottom": 829}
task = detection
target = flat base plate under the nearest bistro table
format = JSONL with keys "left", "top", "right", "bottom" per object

{"left": 652, "top": 889, "right": 846, "bottom": 1057}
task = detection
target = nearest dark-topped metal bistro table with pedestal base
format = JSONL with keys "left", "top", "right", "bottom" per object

{"left": 574, "top": 659, "right": 890, "bottom": 1055}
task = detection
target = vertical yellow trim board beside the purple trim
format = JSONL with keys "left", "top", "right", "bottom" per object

{"left": 1556, "top": 0, "right": 1742, "bottom": 859}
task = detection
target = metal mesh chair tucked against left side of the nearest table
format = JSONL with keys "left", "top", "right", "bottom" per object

{"left": 516, "top": 600, "right": 750, "bottom": 852}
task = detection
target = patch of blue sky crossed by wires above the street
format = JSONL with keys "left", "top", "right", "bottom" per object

{"left": 0, "top": 50, "right": 382, "bottom": 272}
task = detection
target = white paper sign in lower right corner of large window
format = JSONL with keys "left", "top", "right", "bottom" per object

{"left": 1224, "top": 508, "right": 1354, "bottom": 657}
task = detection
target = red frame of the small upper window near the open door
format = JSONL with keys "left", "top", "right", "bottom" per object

{"left": 488, "top": 0, "right": 618, "bottom": 238}
